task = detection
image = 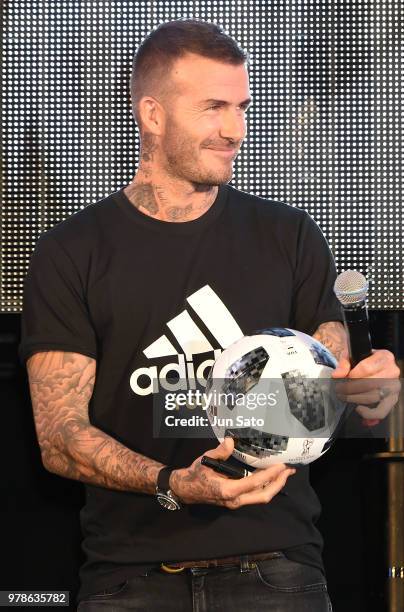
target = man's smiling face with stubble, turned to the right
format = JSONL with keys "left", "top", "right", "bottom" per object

{"left": 157, "top": 54, "right": 250, "bottom": 185}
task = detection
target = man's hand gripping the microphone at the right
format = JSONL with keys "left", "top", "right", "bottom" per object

{"left": 332, "top": 349, "right": 401, "bottom": 427}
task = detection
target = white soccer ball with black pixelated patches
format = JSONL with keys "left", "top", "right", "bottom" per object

{"left": 205, "top": 327, "right": 345, "bottom": 468}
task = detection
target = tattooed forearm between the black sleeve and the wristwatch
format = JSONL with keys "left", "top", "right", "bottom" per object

{"left": 27, "top": 351, "right": 163, "bottom": 493}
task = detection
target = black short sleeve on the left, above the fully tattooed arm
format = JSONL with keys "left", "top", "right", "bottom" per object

{"left": 18, "top": 234, "right": 97, "bottom": 365}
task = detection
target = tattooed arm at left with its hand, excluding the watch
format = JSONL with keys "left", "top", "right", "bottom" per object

{"left": 27, "top": 351, "right": 294, "bottom": 509}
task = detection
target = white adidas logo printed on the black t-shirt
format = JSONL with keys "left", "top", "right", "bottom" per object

{"left": 130, "top": 285, "right": 243, "bottom": 396}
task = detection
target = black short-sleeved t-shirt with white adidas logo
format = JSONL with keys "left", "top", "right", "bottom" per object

{"left": 19, "top": 185, "right": 342, "bottom": 599}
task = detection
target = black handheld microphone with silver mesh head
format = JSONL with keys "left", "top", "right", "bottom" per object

{"left": 334, "top": 270, "right": 372, "bottom": 368}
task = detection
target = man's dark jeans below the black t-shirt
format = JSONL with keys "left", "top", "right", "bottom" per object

{"left": 77, "top": 553, "right": 332, "bottom": 612}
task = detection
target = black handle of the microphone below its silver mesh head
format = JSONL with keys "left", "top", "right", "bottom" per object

{"left": 343, "top": 301, "right": 372, "bottom": 368}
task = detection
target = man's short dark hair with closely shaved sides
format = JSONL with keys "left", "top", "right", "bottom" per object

{"left": 130, "top": 19, "right": 249, "bottom": 128}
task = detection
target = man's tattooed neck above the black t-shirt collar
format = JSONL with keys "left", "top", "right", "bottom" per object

{"left": 124, "top": 162, "right": 218, "bottom": 223}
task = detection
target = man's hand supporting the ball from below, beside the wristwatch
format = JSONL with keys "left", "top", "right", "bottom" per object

{"left": 170, "top": 437, "right": 296, "bottom": 510}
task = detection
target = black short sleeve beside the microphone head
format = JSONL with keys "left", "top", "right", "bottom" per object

{"left": 292, "top": 212, "right": 343, "bottom": 335}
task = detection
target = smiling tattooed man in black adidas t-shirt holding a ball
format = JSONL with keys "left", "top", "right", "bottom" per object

{"left": 20, "top": 20, "right": 398, "bottom": 612}
